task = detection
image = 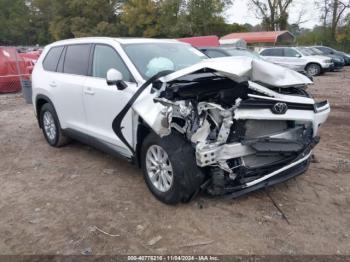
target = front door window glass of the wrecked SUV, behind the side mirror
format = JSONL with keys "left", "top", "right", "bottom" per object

{"left": 92, "top": 45, "right": 132, "bottom": 82}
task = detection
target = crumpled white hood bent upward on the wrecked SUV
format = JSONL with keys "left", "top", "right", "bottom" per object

{"left": 160, "top": 57, "right": 313, "bottom": 87}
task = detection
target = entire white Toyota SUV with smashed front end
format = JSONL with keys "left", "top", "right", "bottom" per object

{"left": 32, "top": 38, "right": 330, "bottom": 204}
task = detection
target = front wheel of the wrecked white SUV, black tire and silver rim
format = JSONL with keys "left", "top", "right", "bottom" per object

{"left": 141, "top": 133, "right": 205, "bottom": 205}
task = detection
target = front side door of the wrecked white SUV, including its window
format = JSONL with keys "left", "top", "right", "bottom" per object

{"left": 83, "top": 44, "right": 136, "bottom": 155}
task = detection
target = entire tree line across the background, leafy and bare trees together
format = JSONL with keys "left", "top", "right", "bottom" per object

{"left": 0, "top": 0, "right": 350, "bottom": 51}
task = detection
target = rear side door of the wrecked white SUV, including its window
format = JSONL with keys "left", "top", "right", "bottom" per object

{"left": 50, "top": 44, "right": 91, "bottom": 132}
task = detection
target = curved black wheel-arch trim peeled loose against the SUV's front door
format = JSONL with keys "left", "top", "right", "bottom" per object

{"left": 112, "top": 70, "right": 173, "bottom": 156}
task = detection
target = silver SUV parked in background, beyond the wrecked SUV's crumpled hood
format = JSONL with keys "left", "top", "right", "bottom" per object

{"left": 260, "top": 47, "right": 334, "bottom": 76}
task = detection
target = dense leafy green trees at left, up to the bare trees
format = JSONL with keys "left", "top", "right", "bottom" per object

{"left": 0, "top": 0, "right": 243, "bottom": 45}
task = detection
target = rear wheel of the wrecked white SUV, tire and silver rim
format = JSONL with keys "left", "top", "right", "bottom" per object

{"left": 39, "top": 103, "right": 70, "bottom": 147}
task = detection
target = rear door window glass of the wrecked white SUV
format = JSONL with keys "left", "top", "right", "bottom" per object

{"left": 63, "top": 44, "right": 90, "bottom": 76}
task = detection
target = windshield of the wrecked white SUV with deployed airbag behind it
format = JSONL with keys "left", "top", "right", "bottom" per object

{"left": 123, "top": 43, "right": 207, "bottom": 79}
